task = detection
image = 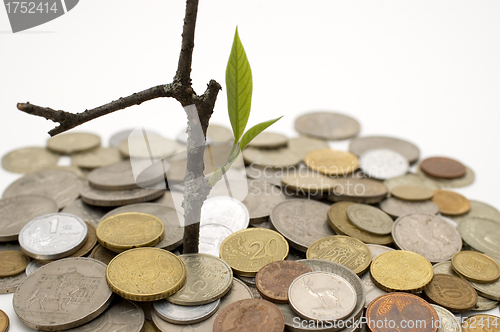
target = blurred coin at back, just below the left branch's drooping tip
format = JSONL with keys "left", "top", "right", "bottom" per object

{"left": 47, "top": 133, "right": 101, "bottom": 154}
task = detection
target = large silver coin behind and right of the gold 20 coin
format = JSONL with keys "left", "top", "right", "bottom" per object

{"left": 271, "top": 199, "right": 335, "bottom": 252}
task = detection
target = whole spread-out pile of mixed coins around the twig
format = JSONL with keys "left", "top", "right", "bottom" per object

{"left": 0, "top": 111, "right": 500, "bottom": 332}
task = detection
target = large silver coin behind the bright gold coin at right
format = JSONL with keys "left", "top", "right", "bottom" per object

{"left": 392, "top": 213, "right": 462, "bottom": 263}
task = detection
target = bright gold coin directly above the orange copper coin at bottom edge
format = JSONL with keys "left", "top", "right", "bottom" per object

{"left": 370, "top": 250, "right": 434, "bottom": 293}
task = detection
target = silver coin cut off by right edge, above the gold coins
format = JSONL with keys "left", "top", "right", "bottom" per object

{"left": 457, "top": 217, "right": 500, "bottom": 257}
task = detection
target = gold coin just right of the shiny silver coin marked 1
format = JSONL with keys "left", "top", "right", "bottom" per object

{"left": 97, "top": 212, "right": 165, "bottom": 253}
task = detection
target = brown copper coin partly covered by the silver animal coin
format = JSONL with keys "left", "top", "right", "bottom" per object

{"left": 255, "top": 261, "right": 312, "bottom": 303}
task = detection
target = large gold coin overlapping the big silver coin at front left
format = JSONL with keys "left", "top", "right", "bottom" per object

{"left": 106, "top": 248, "right": 186, "bottom": 301}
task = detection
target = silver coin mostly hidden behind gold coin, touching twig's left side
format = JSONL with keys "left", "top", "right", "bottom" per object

{"left": 101, "top": 203, "right": 184, "bottom": 250}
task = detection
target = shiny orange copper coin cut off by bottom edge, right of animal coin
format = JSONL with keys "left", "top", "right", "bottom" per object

{"left": 365, "top": 293, "right": 439, "bottom": 332}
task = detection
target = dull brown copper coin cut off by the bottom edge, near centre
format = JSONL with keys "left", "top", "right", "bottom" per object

{"left": 213, "top": 299, "right": 285, "bottom": 332}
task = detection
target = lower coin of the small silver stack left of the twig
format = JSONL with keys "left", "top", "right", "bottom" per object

{"left": 80, "top": 185, "right": 165, "bottom": 206}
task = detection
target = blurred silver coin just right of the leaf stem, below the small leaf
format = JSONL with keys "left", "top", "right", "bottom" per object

{"left": 243, "top": 147, "right": 302, "bottom": 167}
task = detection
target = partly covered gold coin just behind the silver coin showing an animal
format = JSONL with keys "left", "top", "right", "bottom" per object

{"left": 306, "top": 235, "right": 372, "bottom": 275}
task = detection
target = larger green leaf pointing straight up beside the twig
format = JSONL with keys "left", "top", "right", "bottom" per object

{"left": 226, "top": 27, "right": 252, "bottom": 143}
